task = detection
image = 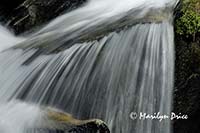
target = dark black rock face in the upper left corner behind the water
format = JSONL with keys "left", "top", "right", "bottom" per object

{"left": 2, "top": 0, "right": 86, "bottom": 34}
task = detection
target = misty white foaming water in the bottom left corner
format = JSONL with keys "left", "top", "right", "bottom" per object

{"left": 0, "top": 101, "right": 42, "bottom": 133}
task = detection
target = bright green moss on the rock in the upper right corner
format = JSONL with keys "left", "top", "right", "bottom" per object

{"left": 175, "top": 0, "right": 200, "bottom": 41}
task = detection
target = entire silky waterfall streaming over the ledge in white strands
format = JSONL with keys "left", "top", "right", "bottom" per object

{"left": 0, "top": 0, "right": 176, "bottom": 133}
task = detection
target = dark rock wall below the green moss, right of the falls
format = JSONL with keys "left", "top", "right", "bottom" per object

{"left": 174, "top": 36, "right": 200, "bottom": 133}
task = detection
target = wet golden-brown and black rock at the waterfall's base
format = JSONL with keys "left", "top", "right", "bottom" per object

{"left": 43, "top": 108, "right": 110, "bottom": 133}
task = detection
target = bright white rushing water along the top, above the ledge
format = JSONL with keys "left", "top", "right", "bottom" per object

{"left": 33, "top": 0, "right": 178, "bottom": 36}
